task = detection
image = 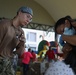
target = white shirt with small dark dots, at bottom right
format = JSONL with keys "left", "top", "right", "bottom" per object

{"left": 45, "top": 61, "right": 75, "bottom": 75}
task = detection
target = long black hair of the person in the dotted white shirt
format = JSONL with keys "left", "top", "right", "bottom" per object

{"left": 64, "top": 46, "right": 76, "bottom": 74}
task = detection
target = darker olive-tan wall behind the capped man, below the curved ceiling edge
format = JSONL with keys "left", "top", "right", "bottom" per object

{"left": 0, "top": 0, "right": 55, "bottom": 25}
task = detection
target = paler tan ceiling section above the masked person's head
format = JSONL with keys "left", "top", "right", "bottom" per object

{"left": 34, "top": 0, "right": 76, "bottom": 22}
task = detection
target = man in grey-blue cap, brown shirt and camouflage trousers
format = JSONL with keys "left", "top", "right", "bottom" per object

{"left": 0, "top": 7, "right": 33, "bottom": 75}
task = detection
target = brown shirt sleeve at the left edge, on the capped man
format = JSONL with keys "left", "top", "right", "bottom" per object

{"left": 0, "top": 22, "right": 11, "bottom": 50}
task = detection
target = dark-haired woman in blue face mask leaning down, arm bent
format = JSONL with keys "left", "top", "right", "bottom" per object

{"left": 54, "top": 17, "right": 76, "bottom": 46}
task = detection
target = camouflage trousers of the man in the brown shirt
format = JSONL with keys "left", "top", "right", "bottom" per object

{"left": 0, "top": 58, "right": 15, "bottom": 75}
